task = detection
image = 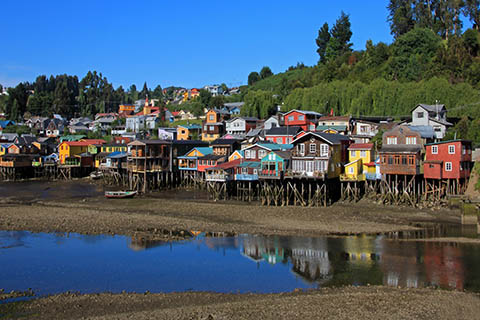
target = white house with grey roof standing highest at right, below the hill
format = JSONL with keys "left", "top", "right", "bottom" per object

{"left": 408, "top": 104, "right": 452, "bottom": 139}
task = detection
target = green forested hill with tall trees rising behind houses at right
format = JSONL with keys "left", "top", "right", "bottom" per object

{"left": 243, "top": 0, "right": 480, "bottom": 125}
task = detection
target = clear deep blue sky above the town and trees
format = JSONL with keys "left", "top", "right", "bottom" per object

{"left": 0, "top": 0, "right": 424, "bottom": 89}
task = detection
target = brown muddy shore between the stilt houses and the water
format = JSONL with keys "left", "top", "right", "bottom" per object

{"left": 0, "top": 197, "right": 460, "bottom": 237}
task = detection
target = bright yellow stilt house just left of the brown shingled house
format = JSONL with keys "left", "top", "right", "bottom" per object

{"left": 341, "top": 143, "right": 375, "bottom": 181}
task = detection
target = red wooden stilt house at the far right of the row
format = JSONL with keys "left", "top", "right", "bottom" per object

{"left": 423, "top": 140, "right": 472, "bottom": 179}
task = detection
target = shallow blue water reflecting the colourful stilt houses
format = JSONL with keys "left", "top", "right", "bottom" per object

{"left": 0, "top": 231, "right": 480, "bottom": 295}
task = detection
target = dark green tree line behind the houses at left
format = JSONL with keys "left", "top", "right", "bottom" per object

{"left": 0, "top": 71, "right": 163, "bottom": 120}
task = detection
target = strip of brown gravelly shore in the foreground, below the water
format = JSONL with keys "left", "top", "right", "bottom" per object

{"left": 0, "top": 287, "right": 480, "bottom": 320}
